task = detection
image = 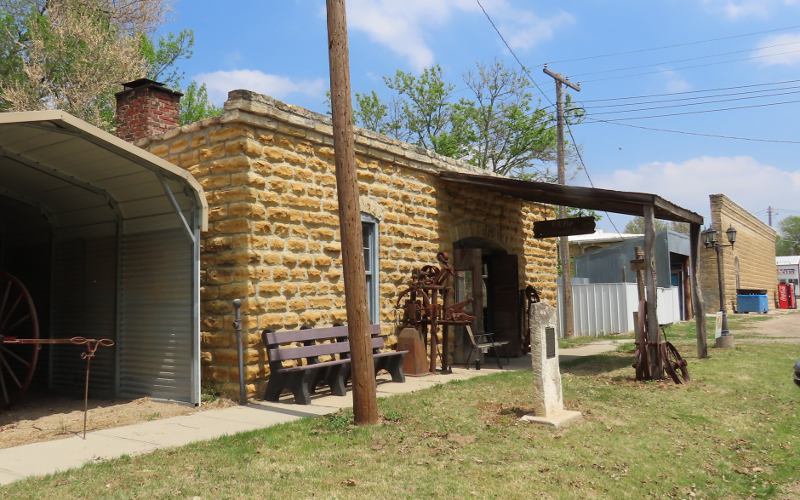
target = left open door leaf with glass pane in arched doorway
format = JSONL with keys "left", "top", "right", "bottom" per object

{"left": 453, "top": 248, "right": 484, "bottom": 363}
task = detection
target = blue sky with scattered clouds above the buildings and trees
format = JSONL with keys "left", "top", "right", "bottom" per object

{"left": 156, "top": 0, "right": 800, "bottom": 231}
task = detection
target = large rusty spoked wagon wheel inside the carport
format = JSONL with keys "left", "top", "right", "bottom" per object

{"left": 0, "top": 271, "right": 39, "bottom": 408}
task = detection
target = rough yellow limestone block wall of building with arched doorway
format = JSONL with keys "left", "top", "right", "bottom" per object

{"left": 140, "top": 91, "right": 556, "bottom": 394}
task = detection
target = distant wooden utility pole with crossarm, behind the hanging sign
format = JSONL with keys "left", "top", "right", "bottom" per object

{"left": 544, "top": 66, "right": 581, "bottom": 337}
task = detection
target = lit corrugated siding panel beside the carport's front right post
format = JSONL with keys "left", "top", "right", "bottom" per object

{"left": 118, "top": 229, "right": 193, "bottom": 402}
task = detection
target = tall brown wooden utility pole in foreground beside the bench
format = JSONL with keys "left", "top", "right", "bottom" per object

{"left": 326, "top": 0, "right": 378, "bottom": 425}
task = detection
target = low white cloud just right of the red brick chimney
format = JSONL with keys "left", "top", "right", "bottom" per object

{"left": 194, "top": 69, "right": 326, "bottom": 104}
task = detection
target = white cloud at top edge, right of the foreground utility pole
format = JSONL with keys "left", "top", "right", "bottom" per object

{"left": 347, "top": 0, "right": 573, "bottom": 71}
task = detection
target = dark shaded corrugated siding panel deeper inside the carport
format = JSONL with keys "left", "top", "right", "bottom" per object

{"left": 50, "top": 237, "right": 117, "bottom": 397}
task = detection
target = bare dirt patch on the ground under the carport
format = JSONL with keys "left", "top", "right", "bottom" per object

{"left": 0, "top": 397, "right": 233, "bottom": 449}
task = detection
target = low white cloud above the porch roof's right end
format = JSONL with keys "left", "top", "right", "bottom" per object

{"left": 595, "top": 156, "right": 800, "bottom": 217}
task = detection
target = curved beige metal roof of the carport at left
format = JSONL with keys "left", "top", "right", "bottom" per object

{"left": 0, "top": 111, "right": 208, "bottom": 230}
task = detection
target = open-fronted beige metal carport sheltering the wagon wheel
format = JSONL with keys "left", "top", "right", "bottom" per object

{"left": 0, "top": 111, "right": 208, "bottom": 404}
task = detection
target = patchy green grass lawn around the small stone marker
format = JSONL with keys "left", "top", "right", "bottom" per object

{"left": 0, "top": 316, "right": 800, "bottom": 498}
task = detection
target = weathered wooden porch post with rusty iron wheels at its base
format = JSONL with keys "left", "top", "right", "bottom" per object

{"left": 644, "top": 205, "right": 664, "bottom": 380}
